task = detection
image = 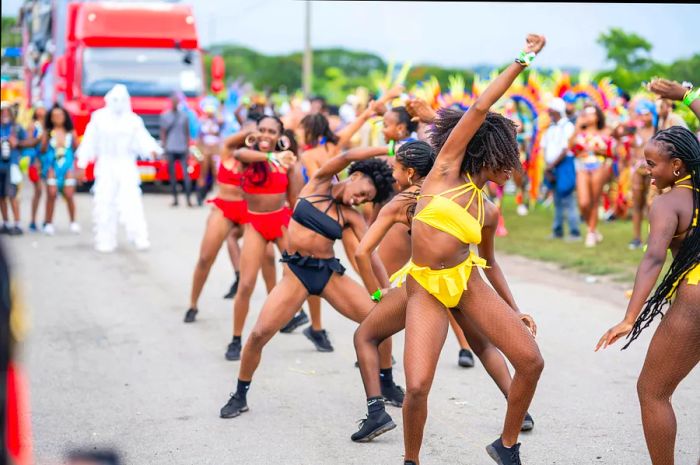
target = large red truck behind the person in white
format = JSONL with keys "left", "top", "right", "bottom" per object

{"left": 22, "top": 0, "right": 221, "bottom": 182}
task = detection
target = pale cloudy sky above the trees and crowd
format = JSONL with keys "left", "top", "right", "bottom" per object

{"left": 2, "top": 0, "right": 700, "bottom": 69}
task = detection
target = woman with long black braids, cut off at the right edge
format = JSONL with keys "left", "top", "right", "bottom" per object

{"left": 596, "top": 76, "right": 700, "bottom": 465}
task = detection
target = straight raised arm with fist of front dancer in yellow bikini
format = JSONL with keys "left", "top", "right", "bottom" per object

{"left": 429, "top": 34, "right": 545, "bottom": 176}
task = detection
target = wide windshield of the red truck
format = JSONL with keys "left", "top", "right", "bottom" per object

{"left": 83, "top": 47, "right": 203, "bottom": 97}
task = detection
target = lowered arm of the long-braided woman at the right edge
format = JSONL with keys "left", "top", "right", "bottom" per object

{"left": 595, "top": 197, "right": 678, "bottom": 351}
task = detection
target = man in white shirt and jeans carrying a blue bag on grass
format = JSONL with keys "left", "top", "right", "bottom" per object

{"left": 541, "top": 98, "right": 581, "bottom": 240}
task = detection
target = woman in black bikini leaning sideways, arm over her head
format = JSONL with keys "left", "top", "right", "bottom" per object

{"left": 220, "top": 148, "right": 403, "bottom": 418}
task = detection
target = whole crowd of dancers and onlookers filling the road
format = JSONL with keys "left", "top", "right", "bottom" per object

{"left": 0, "top": 30, "right": 700, "bottom": 465}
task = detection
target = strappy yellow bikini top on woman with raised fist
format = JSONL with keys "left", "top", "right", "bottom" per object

{"left": 413, "top": 174, "right": 484, "bottom": 244}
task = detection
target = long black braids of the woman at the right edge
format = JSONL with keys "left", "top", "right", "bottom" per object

{"left": 622, "top": 126, "right": 700, "bottom": 350}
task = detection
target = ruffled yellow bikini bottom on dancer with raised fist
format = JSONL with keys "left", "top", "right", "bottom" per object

{"left": 391, "top": 252, "right": 486, "bottom": 308}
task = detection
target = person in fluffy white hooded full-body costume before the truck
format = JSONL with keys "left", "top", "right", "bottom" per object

{"left": 77, "top": 84, "right": 163, "bottom": 252}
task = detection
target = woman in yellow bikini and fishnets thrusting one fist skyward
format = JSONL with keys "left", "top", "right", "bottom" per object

{"left": 398, "top": 35, "right": 545, "bottom": 465}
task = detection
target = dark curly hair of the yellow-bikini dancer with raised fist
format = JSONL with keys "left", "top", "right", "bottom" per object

{"left": 430, "top": 108, "right": 522, "bottom": 174}
